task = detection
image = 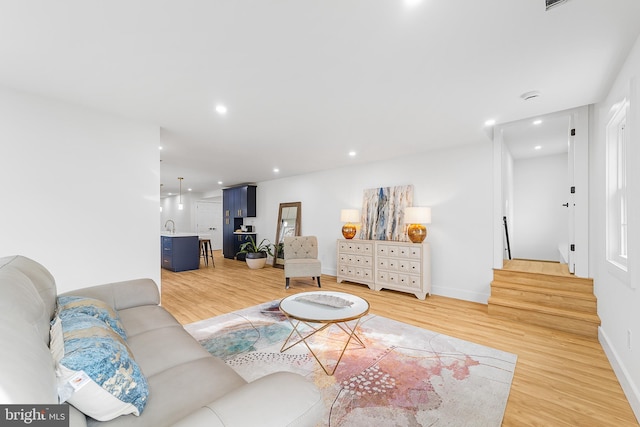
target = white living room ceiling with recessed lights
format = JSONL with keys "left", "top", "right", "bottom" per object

{"left": 0, "top": 0, "right": 640, "bottom": 192}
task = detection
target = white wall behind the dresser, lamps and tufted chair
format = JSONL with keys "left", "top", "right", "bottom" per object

{"left": 255, "top": 139, "right": 493, "bottom": 303}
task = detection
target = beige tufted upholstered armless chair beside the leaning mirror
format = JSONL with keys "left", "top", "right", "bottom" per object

{"left": 284, "top": 236, "right": 321, "bottom": 289}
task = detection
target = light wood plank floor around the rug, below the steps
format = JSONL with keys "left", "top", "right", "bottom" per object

{"left": 162, "top": 252, "right": 639, "bottom": 427}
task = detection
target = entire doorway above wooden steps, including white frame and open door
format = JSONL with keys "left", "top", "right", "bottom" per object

{"left": 493, "top": 107, "right": 588, "bottom": 277}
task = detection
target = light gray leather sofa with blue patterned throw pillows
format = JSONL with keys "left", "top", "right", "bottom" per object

{"left": 0, "top": 256, "right": 323, "bottom": 427}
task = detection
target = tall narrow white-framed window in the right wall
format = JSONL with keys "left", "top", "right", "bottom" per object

{"left": 607, "top": 100, "right": 629, "bottom": 280}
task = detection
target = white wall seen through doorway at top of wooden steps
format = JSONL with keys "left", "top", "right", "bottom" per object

{"left": 511, "top": 153, "right": 569, "bottom": 261}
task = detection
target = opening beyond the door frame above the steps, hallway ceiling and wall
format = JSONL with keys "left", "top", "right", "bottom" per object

{"left": 503, "top": 115, "right": 570, "bottom": 264}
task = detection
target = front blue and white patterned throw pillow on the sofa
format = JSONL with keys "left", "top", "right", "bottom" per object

{"left": 51, "top": 313, "right": 149, "bottom": 421}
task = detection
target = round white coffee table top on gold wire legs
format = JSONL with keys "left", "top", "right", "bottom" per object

{"left": 280, "top": 291, "right": 369, "bottom": 323}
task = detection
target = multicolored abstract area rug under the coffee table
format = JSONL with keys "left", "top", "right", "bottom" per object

{"left": 185, "top": 301, "right": 517, "bottom": 427}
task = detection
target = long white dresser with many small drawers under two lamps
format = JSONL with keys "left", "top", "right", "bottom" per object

{"left": 337, "top": 239, "right": 431, "bottom": 299}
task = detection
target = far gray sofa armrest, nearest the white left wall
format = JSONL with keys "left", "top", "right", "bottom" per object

{"left": 62, "top": 279, "right": 160, "bottom": 310}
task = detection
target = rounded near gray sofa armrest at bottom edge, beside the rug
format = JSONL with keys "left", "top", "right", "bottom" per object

{"left": 174, "top": 372, "right": 325, "bottom": 427}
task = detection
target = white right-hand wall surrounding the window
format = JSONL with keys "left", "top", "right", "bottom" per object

{"left": 589, "top": 34, "right": 640, "bottom": 420}
